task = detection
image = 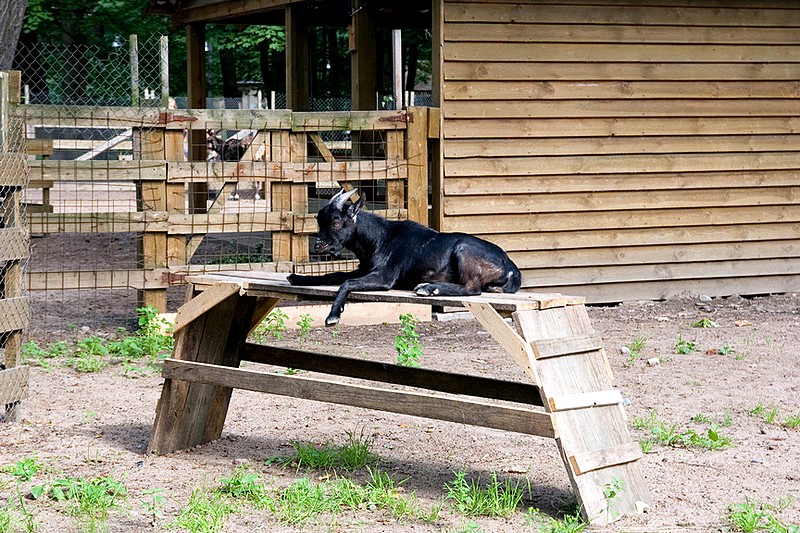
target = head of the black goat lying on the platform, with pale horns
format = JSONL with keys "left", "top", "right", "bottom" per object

{"left": 314, "top": 189, "right": 364, "bottom": 258}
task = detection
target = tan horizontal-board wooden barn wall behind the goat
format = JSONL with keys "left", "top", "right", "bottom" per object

{"left": 441, "top": 0, "right": 800, "bottom": 302}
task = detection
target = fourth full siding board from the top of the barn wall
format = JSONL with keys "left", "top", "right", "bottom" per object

{"left": 444, "top": 61, "right": 797, "bottom": 82}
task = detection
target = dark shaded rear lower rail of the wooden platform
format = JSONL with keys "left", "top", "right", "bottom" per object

{"left": 242, "top": 343, "right": 542, "bottom": 406}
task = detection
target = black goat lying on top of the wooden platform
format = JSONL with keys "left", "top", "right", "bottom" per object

{"left": 288, "top": 190, "right": 522, "bottom": 326}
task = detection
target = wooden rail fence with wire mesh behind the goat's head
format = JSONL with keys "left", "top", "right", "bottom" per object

{"left": 10, "top": 97, "right": 438, "bottom": 309}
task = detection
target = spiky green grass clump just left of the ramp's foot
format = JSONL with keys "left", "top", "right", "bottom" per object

{"left": 444, "top": 470, "right": 523, "bottom": 516}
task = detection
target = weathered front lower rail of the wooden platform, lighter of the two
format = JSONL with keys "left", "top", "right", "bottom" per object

{"left": 162, "top": 359, "right": 555, "bottom": 438}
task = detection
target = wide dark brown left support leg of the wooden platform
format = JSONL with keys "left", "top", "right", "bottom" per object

{"left": 147, "top": 286, "right": 266, "bottom": 454}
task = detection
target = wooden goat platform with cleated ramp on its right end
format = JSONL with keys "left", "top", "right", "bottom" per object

{"left": 148, "top": 272, "right": 652, "bottom": 524}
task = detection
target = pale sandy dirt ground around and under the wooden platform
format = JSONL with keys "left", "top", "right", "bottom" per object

{"left": 0, "top": 294, "right": 800, "bottom": 532}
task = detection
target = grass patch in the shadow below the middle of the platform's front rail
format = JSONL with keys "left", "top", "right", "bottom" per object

{"left": 281, "top": 430, "right": 379, "bottom": 471}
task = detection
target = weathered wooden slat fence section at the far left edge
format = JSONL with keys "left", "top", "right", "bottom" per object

{"left": 0, "top": 72, "right": 30, "bottom": 421}
